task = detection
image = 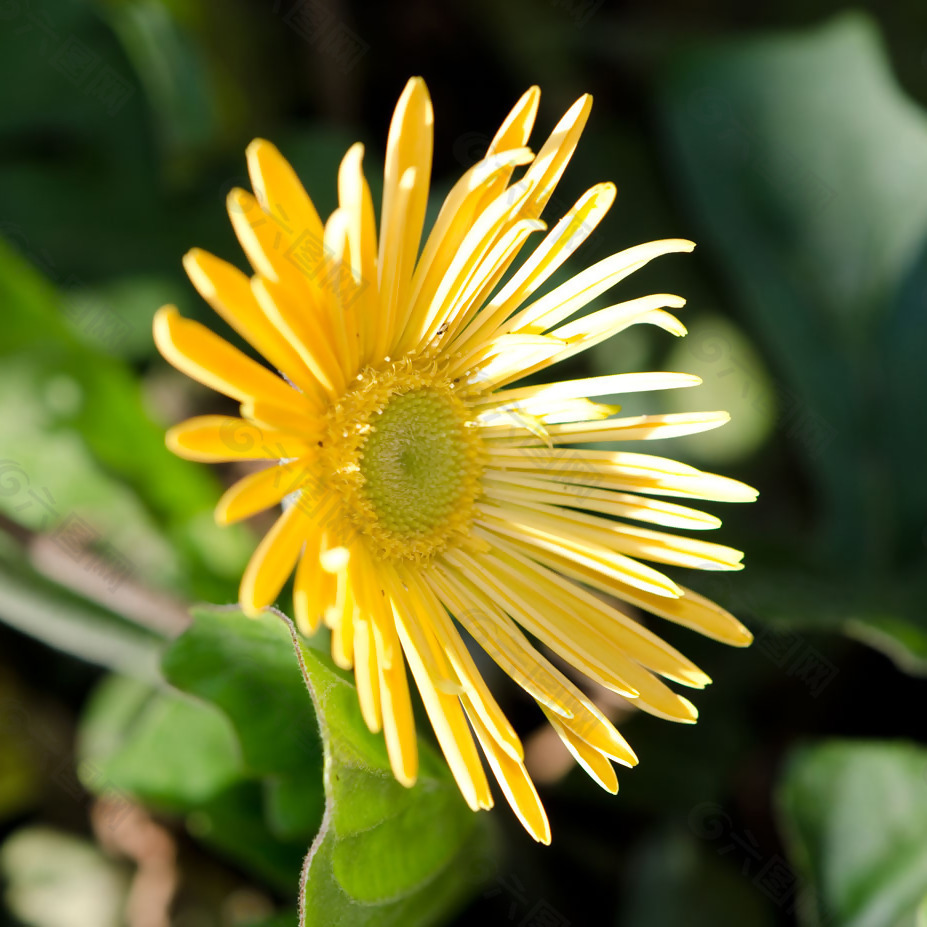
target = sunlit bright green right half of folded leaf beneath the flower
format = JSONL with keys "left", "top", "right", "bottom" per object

{"left": 290, "top": 612, "right": 490, "bottom": 927}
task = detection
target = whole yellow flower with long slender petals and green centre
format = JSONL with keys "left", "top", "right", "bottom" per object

{"left": 154, "top": 78, "right": 756, "bottom": 843}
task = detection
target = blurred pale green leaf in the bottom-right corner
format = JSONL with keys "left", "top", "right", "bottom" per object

{"left": 778, "top": 740, "right": 927, "bottom": 927}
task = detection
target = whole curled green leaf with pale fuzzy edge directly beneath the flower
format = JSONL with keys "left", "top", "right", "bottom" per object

{"left": 162, "top": 608, "right": 488, "bottom": 927}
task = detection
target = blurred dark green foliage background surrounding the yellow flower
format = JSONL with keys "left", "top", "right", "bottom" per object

{"left": 0, "top": 0, "right": 927, "bottom": 927}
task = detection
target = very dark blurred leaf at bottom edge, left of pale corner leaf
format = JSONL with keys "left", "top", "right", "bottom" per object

{"left": 616, "top": 831, "right": 774, "bottom": 927}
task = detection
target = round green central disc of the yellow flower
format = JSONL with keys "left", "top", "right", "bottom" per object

{"left": 360, "top": 389, "right": 473, "bottom": 537}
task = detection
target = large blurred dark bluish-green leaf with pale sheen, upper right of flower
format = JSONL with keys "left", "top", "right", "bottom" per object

{"left": 660, "top": 14, "right": 927, "bottom": 670}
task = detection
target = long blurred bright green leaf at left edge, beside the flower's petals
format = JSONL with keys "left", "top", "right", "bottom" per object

{"left": 0, "top": 234, "right": 252, "bottom": 600}
